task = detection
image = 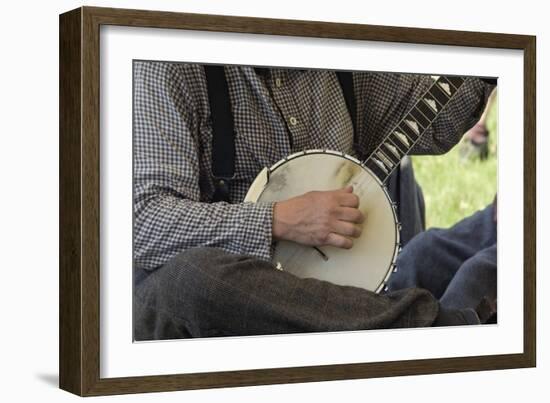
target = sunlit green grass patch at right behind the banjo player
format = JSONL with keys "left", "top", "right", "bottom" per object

{"left": 412, "top": 93, "right": 498, "bottom": 228}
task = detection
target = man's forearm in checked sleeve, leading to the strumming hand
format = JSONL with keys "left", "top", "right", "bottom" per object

{"left": 134, "top": 195, "right": 273, "bottom": 269}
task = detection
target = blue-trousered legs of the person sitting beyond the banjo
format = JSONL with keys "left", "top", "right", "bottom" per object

{"left": 388, "top": 198, "right": 497, "bottom": 318}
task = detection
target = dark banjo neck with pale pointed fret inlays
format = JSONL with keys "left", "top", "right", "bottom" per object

{"left": 363, "top": 76, "right": 465, "bottom": 183}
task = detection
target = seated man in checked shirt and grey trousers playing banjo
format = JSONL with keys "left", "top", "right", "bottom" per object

{"left": 134, "top": 62, "right": 493, "bottom": 340}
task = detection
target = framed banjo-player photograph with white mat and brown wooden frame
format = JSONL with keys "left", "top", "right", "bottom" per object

{"left": 60, "top": 7, "right": 536, "bottom": 396}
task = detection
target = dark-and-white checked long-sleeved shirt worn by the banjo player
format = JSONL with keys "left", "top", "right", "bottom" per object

{"left": 133, "top": 61, "right": 491, "bottom": 270}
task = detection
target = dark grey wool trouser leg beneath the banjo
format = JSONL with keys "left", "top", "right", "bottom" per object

{"left": 134, "top": 248, "right": 439, "bottom": 341}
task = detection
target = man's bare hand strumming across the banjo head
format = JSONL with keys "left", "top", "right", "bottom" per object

{"left": 273, "top": 186, "right": 365, "bottom": 249}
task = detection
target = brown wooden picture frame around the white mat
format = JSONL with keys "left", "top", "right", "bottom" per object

{"left": 59, "top": 7, "right": 536, "bottom": 396}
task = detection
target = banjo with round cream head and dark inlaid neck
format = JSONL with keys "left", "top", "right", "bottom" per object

{"left": 244, "top": 76, "right": 464, "bottom": 293}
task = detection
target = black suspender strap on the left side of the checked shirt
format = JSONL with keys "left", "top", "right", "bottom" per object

{"left": 204, "top": 65, "right": 235, "bottom": 202}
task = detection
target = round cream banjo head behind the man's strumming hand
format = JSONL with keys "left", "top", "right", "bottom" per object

{"left": 245, "top": 150, "right": 399, "bottom": 292}
